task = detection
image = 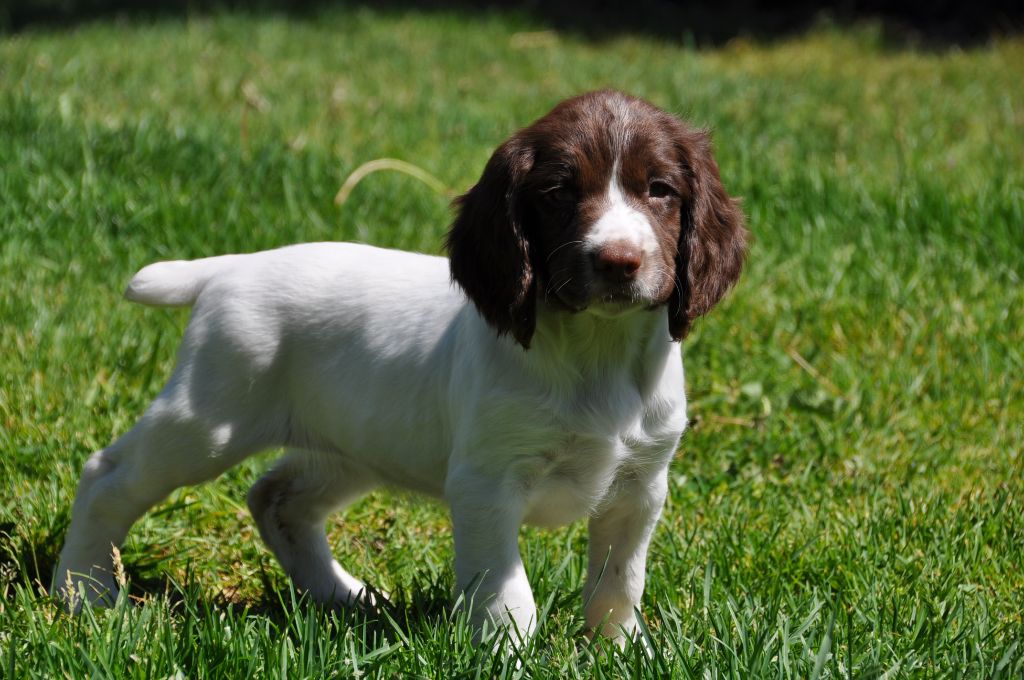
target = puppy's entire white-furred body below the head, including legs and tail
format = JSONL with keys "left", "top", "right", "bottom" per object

{"left": 55, "top": 243, "right": 686, "bottom": 640}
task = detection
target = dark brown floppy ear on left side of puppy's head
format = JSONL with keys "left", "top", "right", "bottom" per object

{"left": 445, "top": 135, "right": 537, "bottom": 349}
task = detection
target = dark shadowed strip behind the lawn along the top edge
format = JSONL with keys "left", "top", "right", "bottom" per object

{"left": 0, "top": 0, "right": 1024, "bottom": 47}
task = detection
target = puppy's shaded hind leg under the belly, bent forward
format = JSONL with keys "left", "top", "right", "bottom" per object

{"left": 248, "top": 449, "right": 376, "bottom": 605}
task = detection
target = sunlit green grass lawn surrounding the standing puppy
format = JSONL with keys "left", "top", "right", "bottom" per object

{"left": 0, "top": 9, "right": 1024, "bottom": 678}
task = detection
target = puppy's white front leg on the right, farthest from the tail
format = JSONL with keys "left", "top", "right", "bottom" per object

{"left": 583, "top": 469, "right": 668, "bottom": 646}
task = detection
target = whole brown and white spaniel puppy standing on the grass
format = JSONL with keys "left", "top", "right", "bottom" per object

{"left": 54, "top": 91, "right": 748, "bottom": 643}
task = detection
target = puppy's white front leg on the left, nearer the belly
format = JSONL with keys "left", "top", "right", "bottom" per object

{"left": 445, "top": 466, "right": 537, "bottom": 642}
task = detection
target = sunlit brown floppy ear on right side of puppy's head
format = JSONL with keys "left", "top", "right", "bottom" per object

{"left": 669, "top": 128, "right": 749, "bottom": 340}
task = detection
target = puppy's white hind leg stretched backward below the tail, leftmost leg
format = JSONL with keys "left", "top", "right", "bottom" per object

{"left": 53, "top": 376, "right": 268, "bottom": 609}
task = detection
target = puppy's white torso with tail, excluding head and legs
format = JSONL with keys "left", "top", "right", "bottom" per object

{"left": 128, "top": 243, "right": 686, "bottom": 526}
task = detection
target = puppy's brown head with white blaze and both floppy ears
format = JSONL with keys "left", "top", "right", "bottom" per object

{"left": 447, "top": 90, "right": 748, "bottom": 347}
